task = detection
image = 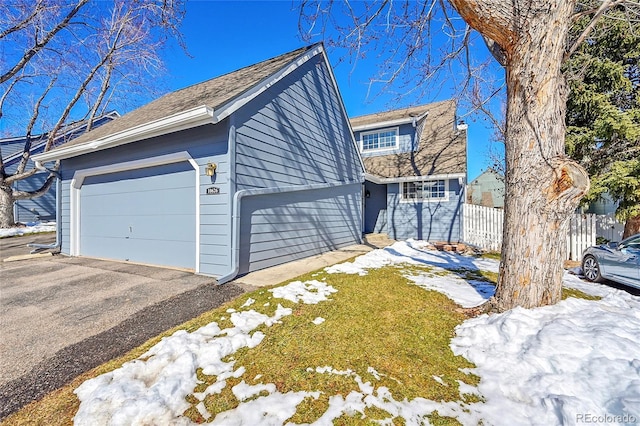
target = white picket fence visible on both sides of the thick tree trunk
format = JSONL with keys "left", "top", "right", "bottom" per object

{"left": 463, "top": 204, "right": 596, "bottom": 260}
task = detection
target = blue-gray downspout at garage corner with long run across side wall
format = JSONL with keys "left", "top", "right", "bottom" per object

{"left": 218, "top": 178, "right": 362, "bottom": 284}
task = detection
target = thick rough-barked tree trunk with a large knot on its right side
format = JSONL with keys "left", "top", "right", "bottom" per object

{"left": 452, "top": 0, "right": 589, "bottom": 312}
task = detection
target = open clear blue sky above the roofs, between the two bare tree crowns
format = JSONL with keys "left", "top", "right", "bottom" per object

{"left": 158, "top": 0, "right": 499, "bottom": 180}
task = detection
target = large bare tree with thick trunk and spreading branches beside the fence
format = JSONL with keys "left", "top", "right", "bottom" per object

{"left": 300, "top": 0, "right": 640, "bottom": 311}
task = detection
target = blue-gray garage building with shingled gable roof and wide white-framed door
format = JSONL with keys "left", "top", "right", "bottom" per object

{"left": 34, "top": 44, "right": 364, "bottom": 283}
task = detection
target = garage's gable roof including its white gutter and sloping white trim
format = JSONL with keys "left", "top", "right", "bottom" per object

{"left": 34, "top": 43, "right": 324, "bottom": 162}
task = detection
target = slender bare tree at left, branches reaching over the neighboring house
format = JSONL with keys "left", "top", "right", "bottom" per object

{"left": 0, "top": 0, "right": 184, "bottom": 228}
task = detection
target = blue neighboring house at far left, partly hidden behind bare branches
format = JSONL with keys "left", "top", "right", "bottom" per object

{"left": 0, "top": 111, "right": 119, "bottom": 223}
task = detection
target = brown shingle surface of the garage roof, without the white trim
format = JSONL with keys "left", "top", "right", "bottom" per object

{"left": 57, "top": 46, "right": 315, "bottom": 151}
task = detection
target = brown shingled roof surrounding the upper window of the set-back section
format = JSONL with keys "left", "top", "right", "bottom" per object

{"left": 350, "top": 100, "right": 467, "bottom": 178}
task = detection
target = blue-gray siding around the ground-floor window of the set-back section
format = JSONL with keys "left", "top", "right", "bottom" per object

{"left": 387, "top": 179, "right": 464, "bottom": 242}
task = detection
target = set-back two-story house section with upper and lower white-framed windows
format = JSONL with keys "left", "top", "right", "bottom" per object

{"left": 351, "top": 100, "right": 467, "bottom": 242}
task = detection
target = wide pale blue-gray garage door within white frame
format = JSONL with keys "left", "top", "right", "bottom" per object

{"left": 80, "top": 162, "right": 196, "bottom": 269}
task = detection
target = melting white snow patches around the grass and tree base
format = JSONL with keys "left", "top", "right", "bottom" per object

{"left": 75, "top": 240, "right": 640, "bottom": 425}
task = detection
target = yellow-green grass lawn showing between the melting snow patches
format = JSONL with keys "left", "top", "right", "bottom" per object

{"left": 3, "top": 255, "right": 596, "bottom": 425}
